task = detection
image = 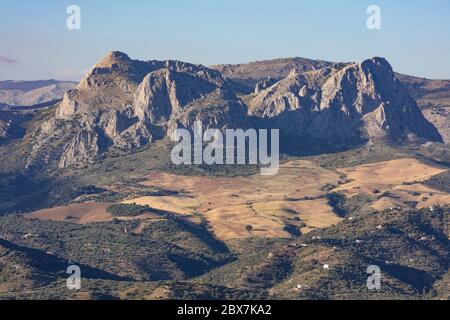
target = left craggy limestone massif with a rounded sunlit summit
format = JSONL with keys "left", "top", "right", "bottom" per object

{"left": 29, "top": 52, "right": 246, "bottom": 167}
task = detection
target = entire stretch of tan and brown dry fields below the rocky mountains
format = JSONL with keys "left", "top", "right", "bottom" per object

{"left": 27, "top": 159, "right": 450, "bottom": 241}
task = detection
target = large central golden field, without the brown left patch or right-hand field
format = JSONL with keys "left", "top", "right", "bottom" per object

{"left": 136, "top": 160, "right": 340, "bottom": 240}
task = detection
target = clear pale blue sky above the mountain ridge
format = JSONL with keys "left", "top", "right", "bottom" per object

{"left": 0, "top": 0, "right": 450, "bottom": 80}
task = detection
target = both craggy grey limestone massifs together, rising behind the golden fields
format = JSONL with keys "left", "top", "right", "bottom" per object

{"left": 28, "top": 52, "right": 440, "bottom": 167}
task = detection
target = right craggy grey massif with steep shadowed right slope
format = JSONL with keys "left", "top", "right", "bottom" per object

{"left": 250, "top": 58, "right": 441, "bottom": 142}
